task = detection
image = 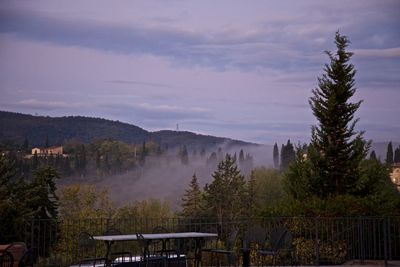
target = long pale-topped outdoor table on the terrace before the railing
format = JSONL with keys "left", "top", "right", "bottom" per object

{"left": 93, "top": 232, "right": 218, "bottom": 267}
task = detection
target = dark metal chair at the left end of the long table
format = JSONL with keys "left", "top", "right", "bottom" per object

{"left": 78, "top": 232, "right": 107, "bottom": 267}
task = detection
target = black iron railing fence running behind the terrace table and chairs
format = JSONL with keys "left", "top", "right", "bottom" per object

{"left": 7, "top": 217, "right": 400, "bottom": 266}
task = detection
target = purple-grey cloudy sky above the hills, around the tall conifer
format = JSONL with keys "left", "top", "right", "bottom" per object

{"left": 0, "top": 0, "right": 400, "bottom": 144}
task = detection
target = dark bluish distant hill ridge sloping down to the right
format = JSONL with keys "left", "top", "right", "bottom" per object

{"left": 0, "top": 111, "right": 257, "bottom": 149}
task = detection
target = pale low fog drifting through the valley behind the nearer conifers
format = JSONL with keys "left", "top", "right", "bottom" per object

{"left": 59, "top": 146, "right": 272, "bottom": 210}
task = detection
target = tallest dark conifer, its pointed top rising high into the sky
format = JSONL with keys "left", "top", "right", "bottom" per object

{"left": 309, "top": 32, "right": 369, "bottom": 195}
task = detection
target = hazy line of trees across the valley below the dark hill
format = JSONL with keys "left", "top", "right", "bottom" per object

{"left": 0, "top": 138, "right": 253, "bottom": 179}
